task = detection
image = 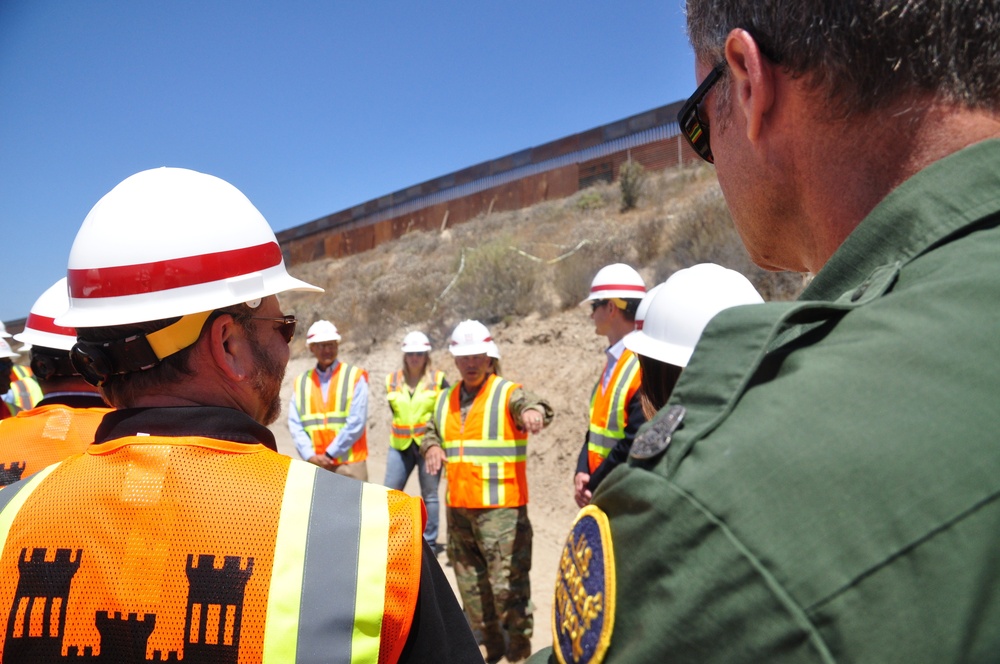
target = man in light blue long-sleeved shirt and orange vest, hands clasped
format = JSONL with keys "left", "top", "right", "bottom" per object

{"left": 288, "top": 320, "right": 368, "bottom": 482}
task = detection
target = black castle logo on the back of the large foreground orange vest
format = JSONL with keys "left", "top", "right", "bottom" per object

{"left": 2, "top": 548, "right": 254, "bottom": 664}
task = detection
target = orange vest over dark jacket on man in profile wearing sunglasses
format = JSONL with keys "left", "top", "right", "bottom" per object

{"left": 587, "top": 348, "right": 642, "bottom": 473}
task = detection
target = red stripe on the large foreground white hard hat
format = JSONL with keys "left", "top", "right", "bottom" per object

{"left": 67, "top": 242, "right": 282, "bottom": 298}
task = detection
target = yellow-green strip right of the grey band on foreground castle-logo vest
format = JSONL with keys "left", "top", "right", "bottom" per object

{"left": 351, "top": 484, "right": 389, "bottom": 662}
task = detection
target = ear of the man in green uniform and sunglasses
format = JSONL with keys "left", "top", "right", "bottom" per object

{"left": 725, "top": 28, "right": 777, "bottom": 143}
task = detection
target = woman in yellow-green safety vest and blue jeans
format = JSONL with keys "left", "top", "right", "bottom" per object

{"left": 385, "top": 332, "right": 448, "bottom": 554}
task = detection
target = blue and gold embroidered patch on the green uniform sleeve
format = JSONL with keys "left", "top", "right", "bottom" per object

{"left": 552, "top": 505, "right": 615, "bottom": 664}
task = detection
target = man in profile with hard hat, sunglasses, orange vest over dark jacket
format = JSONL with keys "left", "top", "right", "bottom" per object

{"left": 573, "top": 263, "right": 646, "bottom": 507}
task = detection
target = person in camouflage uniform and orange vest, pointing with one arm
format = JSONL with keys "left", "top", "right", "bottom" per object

{"left": 421, "top": 320, "right": 553, "bottom": 663}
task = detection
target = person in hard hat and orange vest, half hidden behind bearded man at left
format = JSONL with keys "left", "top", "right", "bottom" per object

{"left": 0, "top": 277, "right": 111, "bottom": 486}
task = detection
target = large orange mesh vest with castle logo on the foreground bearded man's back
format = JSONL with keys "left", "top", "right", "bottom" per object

{"left": 0, "top": 436, "right": 423, "bottom": 663}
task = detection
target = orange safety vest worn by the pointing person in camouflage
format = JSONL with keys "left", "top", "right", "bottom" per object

{"left": 434, "top": 374, "right": 528, "bottom": 508}
